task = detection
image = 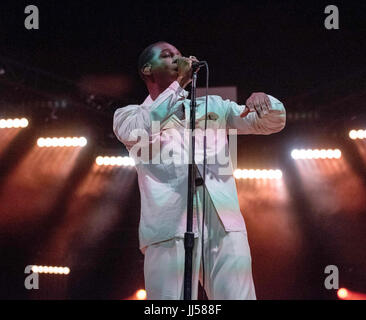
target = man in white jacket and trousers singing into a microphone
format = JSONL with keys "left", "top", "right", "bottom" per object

{"left": 113, "top": 42, "right": 286, "bottom": 300}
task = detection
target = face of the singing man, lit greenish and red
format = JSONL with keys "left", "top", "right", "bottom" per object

{"left": 151, "top": 42, "right": 182, "bottom": 85}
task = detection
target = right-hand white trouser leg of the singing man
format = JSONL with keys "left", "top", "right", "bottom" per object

{"left": 199, "top": 185, "right": 256, "bottom": 300}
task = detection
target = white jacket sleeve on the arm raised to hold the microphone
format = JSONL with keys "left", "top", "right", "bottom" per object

{"left": 113, "top": 81, "right": 188, "bottom": 149}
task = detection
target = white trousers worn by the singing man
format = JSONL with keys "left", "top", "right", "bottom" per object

{"left": 144, "top": 186, "right": 256, "bottom": 300}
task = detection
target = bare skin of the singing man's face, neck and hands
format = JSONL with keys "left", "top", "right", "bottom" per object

{"left": 141, "top": 42, "right": 271, "bottom": 117}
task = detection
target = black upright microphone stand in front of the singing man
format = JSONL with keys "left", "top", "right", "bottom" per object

{"left": 184, "top": 68, "right": 198, "bottom": 300}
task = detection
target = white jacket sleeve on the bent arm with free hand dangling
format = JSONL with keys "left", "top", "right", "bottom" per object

{"left": 223, "top": 95, "right": 286, "bottom": 135}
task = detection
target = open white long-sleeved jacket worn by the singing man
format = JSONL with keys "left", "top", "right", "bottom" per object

{"left": 113, "top": 81, "right": 286, "bottom": 252}
